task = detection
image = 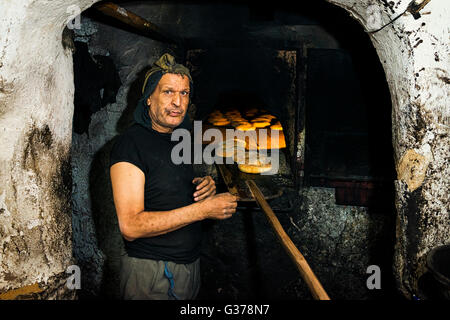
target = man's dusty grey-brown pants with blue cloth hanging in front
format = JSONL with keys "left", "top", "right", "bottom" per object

{"left": 120, "top": 254, "right": 200, "bottom": 300}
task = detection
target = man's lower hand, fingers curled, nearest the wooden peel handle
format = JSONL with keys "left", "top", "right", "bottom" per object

{"left": 201, "top": 192, "right": 238, "bottom": 220}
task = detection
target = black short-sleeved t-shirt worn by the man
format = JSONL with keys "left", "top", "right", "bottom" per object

{"left": 110, "top": 124, "right": 202, "bottom": 263}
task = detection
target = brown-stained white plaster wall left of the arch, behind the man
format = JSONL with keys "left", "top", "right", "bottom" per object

{"left": 0, "top": 0, "right": 100, "bottom": 292}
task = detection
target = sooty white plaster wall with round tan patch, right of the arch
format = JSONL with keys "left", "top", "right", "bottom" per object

{"left": 329, "top": 0, "right": 450, "bottom": 297}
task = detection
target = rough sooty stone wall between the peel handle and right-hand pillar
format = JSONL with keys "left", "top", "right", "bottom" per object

{"left": 286, "top": 187, "right": 398, "bottom": 300}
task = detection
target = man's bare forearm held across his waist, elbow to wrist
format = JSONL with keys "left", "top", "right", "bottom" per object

{"left": 123, "top": 202, "right": 205, "bottom": 240}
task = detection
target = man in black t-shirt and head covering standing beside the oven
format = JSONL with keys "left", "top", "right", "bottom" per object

{"left": 110, "top": 54, "right": 237, "bottom": 299}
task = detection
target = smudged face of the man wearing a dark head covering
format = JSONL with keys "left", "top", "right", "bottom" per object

{"left": 147, "top": 73, "right": 190, "bottom": 133}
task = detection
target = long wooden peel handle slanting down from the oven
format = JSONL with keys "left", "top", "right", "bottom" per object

{"left": 246, "top": 180, "right": 330, "bottom": 300}
